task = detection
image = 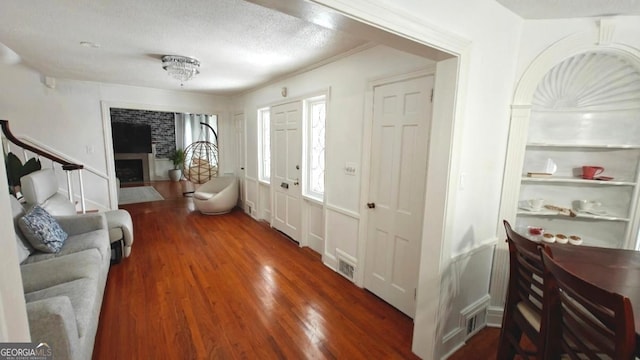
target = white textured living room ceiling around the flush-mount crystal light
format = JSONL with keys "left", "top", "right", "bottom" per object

{"left": 0, "top": 0, "right": 366, "bottom": 94}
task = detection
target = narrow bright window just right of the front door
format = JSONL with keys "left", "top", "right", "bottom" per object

{"left": 303, "top": 95, "right": 327, "bottom": 201}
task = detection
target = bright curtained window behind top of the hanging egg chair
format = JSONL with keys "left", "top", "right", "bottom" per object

{"left": 175, "top": 113, "right": 218, "bottom": 150}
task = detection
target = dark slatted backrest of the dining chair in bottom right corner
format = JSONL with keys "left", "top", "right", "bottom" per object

{"left": 542, "top": 253, "right": 636, "bottom": 360}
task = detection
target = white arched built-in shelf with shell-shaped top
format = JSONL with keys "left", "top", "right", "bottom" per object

{"left": 487, "top": 17, "right": 640, "bottom": 330}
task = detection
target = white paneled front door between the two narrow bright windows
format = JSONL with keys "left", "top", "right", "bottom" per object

{"left": 270, "top": 101, "right": 302, "bottom": 242}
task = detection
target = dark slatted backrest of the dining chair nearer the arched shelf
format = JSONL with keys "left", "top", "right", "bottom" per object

{"left": 504, "top": 220, "right": 544, "bottom": 316}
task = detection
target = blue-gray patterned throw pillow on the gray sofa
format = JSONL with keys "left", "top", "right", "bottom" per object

{"left": 18, "top": 205, "right": 68, "bottom": 253}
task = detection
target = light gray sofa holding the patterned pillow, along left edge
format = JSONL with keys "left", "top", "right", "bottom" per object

{"left": 10, "top": 197, "right": 111, "bottom": 360}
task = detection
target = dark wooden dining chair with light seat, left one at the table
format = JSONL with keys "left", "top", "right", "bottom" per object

{"left": 497, "top": 220, "right": 550, "bottom": 360}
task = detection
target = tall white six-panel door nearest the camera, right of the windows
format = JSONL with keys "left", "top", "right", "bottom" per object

{"left": 365, "top": 76, "right": 433, "bottom": 317}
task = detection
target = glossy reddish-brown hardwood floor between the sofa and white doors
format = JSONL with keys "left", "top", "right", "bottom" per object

{"left": 93, "top": 182, "right": 417, "bottom": 359}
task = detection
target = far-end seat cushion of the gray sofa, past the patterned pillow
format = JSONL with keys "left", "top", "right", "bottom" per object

{"left": 23, "top": 229, "right": 111, "bottom": 264}
